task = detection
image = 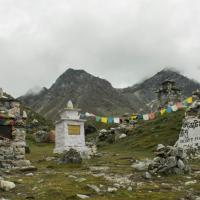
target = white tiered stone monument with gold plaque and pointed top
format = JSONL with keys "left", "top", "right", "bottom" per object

{"left": 54, "top": 101, "right": 87, "bottom": 153}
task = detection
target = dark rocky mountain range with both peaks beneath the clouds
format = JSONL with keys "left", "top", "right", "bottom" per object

{"left": 19, "top": 69, "right": 200, "bottom": 120}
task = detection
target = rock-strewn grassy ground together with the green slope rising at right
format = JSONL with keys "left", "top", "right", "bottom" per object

{"left": 0, "top": 112, "right": 200, "bottom": 200}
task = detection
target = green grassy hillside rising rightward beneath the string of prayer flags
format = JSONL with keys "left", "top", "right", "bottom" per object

{"left": 100, "top": 110, "right": 185, "bottom": 157}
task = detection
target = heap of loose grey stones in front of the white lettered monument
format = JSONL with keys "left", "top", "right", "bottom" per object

{"left": 148, "top": 144, "right": 190, "bottom": 175}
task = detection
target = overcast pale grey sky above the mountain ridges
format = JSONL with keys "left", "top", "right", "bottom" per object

{"left": 0, "top": 0, "right": 200, "bottom": 97}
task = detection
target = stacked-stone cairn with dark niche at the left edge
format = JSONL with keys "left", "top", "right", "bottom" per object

{"left": 0, "top": 88, "right": 30, "bottom": 169}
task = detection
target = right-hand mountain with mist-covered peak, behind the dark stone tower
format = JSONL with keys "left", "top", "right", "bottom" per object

{"left": 121, "top": 69, "right": 200, "bottom": 111}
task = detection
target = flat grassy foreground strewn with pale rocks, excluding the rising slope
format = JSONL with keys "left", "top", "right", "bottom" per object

{"left": 0, "top": 141, "right": 200, "bottom": 200}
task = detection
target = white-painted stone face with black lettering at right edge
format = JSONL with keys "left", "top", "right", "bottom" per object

{"left": 176, "top": 117, "right": 200, "bottom": 149}
